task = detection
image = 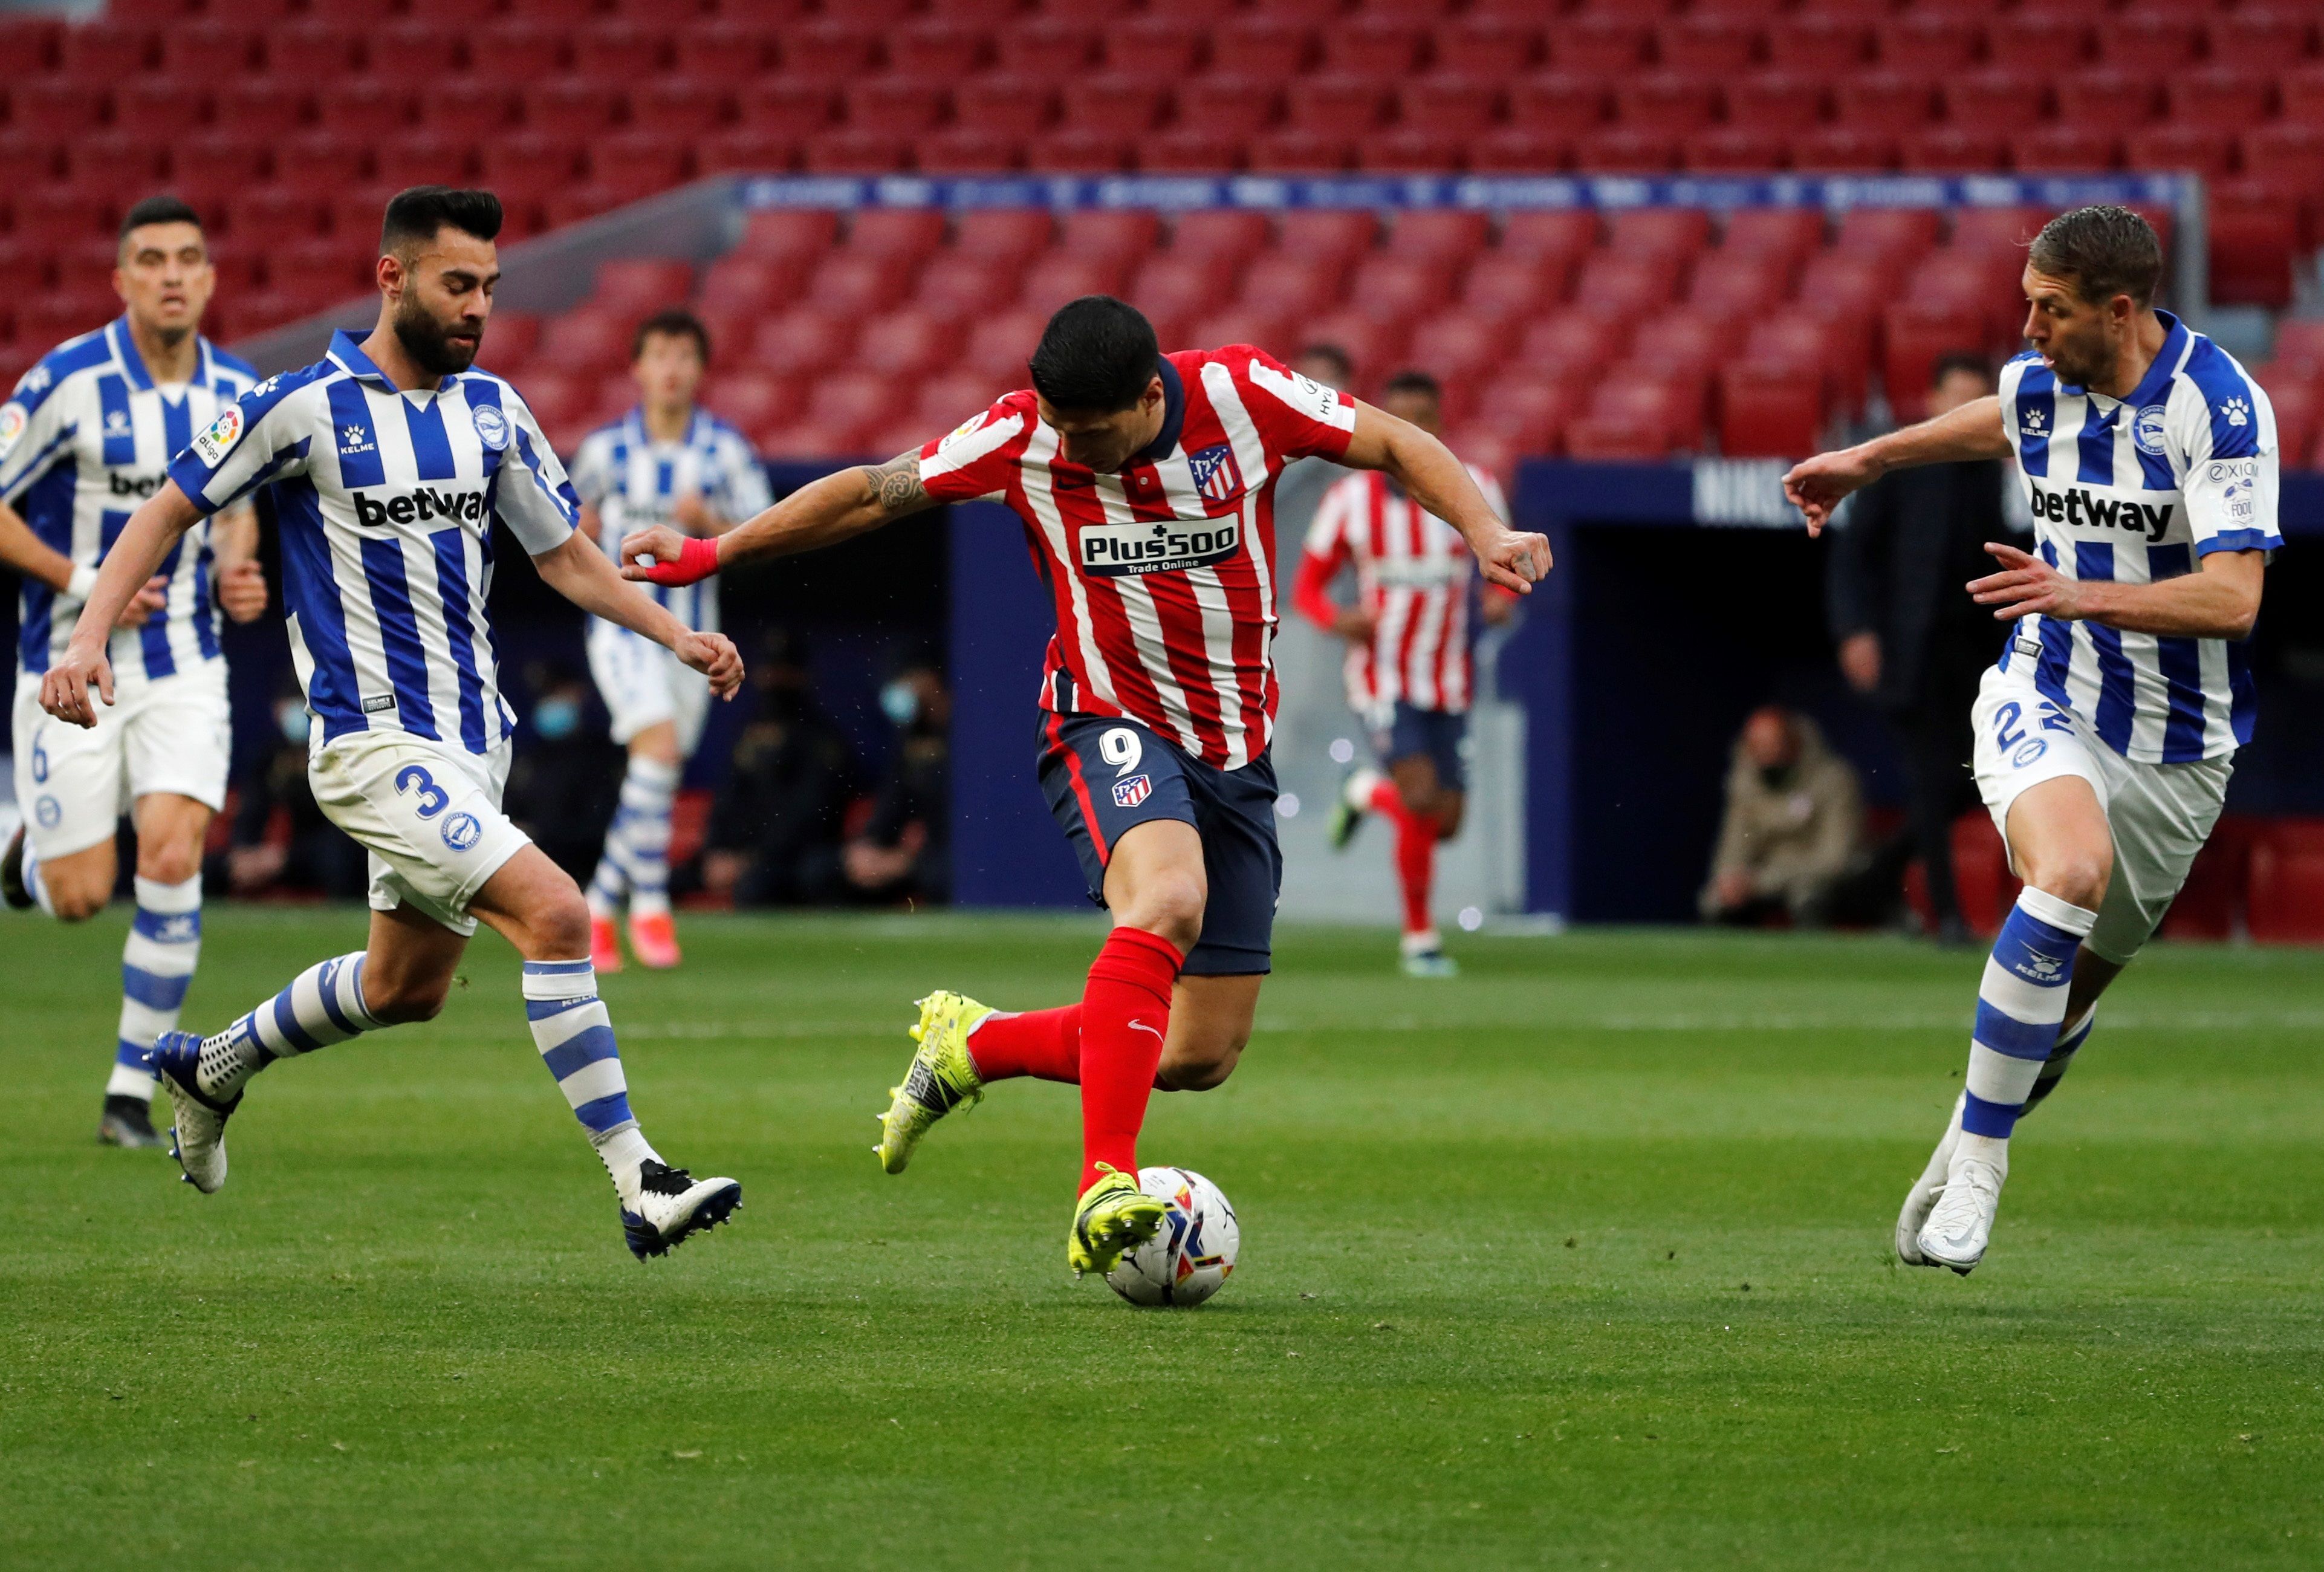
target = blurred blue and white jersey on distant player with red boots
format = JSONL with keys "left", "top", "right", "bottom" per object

{"left": 574, "top": 409, "right": 774, "bottom": 632}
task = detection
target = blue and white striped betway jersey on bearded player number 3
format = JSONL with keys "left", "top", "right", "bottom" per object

{"left": 170, "top": 333, "right": 581, "bottom": 753}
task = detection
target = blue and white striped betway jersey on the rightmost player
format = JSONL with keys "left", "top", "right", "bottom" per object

{"left": 2001, "top": 311, "right": 2285, "bottom": 765}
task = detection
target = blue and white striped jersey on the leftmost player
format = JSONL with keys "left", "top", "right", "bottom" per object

{"left": 0, "top": 316, "right": 258, "bottom": 681}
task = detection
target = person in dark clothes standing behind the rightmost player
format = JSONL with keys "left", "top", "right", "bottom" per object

{"left": 1825, "top": 354, "right": 2010, "bottom": 944}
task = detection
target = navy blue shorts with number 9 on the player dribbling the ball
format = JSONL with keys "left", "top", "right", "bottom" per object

{"left": 1041, "top": 714, "right": 1283, "bottom": 976}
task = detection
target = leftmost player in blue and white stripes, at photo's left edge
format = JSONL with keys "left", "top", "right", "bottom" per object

{"left": 0, "top": 195, "right": 267, "bottom": 1146}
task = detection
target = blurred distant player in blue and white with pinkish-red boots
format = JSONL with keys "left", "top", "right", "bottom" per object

{"left": 572, "top": 310, "right": 771, "bottom": 972}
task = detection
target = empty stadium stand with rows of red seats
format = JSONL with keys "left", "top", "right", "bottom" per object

{"left": 0, "top": 0, "right": 2324, "bottom": 463}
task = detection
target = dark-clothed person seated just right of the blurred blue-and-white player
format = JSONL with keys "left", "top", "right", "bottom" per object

{"left": 699, "top": 628, "right": 857, "bottom": 907}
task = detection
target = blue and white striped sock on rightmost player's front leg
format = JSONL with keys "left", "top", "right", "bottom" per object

{"left": 1961, "top": 886, "right": 2098, "bottom": 1142}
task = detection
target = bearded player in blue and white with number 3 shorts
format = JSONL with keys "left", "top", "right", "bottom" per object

{"left": 42, "top": 186, "right": 741, "bottom": 1261}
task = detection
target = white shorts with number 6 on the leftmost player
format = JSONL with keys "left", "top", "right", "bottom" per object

{"left": 11, "top": 660, "right": 235, "bottom": 860}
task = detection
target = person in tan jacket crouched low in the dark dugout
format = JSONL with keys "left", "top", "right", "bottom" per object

{"left": 1701, "top": 704, "right": 1864, "bottom": 928}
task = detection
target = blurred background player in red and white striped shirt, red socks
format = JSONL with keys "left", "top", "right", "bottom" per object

{"left": 1292, "top": 372, "right": 1517, "bottom": 976}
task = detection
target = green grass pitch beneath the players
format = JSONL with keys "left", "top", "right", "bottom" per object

{"left": 0, "top": 907, "right": 2324, "bottom": 1572}
